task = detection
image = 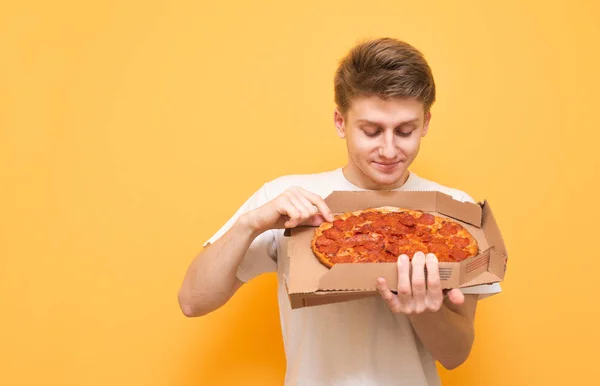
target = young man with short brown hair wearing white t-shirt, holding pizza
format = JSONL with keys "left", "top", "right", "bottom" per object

{"left": 179, "top": 39, "right": 500, "bottom": 386}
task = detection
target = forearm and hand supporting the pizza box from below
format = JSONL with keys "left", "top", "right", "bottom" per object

{"left": 377, "top": 252, "right": 477, "bottom": 369}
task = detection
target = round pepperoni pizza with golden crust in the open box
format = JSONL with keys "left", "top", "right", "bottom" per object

{"left": 311, "top": 206, "right": 479, "bottom": 268}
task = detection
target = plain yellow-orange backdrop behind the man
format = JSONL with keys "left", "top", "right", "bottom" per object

{"left": 0, "top": 0, "right": 600, "bottom": 386}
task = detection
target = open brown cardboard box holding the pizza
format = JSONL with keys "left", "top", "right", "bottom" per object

{"left": 284, "top": 191, "right": 508, "bottom": 309}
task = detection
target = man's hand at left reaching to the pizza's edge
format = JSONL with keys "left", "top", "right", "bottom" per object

{"left": 246, "top": 187, "right": 333, "bottom": 234}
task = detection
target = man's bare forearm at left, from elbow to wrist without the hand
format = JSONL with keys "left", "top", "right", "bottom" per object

{"left": 178, "top": 216, "right": 258, "bottom": 316}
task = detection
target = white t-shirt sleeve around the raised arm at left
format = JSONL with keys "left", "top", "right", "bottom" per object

{"left": 204, "top": 184, "right": 277, "bottom": 282}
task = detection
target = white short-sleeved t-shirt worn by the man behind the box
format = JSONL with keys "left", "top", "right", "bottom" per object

{"left": 205, "top": 168, "right": 501, "bottom": 386}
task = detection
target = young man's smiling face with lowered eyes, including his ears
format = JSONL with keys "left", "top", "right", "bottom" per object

{"left": 334, "top": 96, "right": 431, "bottom": 189}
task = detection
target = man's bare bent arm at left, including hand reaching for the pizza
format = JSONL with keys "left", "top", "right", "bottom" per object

{"left": 178, "top": 188, "right": 333, "bottom": 317}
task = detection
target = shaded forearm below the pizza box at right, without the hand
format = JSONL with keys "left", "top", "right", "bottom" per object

{"left": 408, "top": 298, "right": 476, "bottom": 369}
